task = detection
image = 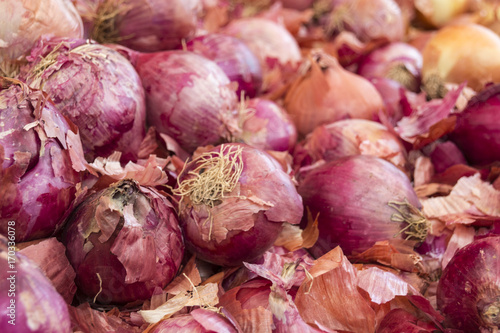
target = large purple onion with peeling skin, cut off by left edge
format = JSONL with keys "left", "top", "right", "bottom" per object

{"left": 0, "top": 79, "right": 85, "bottom": 242}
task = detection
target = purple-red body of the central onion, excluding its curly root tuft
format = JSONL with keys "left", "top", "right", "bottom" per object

{"left": 178, "top": 143, "right": 302, "bottom": 266}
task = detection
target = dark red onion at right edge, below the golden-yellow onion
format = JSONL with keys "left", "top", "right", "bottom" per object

{"left": 450, "top": 84, "right": 500, "bottom": 165}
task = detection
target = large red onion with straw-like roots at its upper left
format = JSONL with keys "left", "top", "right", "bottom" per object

{"left": 21, "top": 39, "right": 146, "bottom": 161}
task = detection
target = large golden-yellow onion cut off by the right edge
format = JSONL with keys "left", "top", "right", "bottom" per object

{"left": 422, "top": 24, "right": 500, "bottom": 91}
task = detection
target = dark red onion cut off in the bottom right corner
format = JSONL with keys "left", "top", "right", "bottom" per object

{"left": 436, "top": 236, "right": 500, "bottom": 333}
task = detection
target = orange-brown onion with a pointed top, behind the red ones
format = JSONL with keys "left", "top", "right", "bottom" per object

{"left": 285, "top": 51, "right": 384, "bottom": 135}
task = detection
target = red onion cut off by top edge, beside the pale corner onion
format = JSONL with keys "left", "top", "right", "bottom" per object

{"left": 76, "top": 0, "right": 201, "bottom": 52}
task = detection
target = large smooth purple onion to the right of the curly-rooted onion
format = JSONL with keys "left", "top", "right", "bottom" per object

{"left": 298, "top": 155, "right": 420, "bottom": 257}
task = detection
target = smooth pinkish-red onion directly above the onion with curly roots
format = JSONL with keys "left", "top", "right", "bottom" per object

{"left": 135, "top": 51, "right": 238, "bottom": 152}
